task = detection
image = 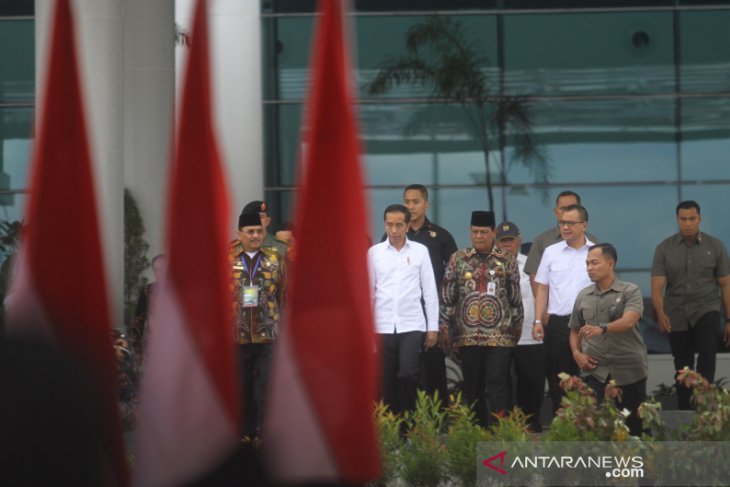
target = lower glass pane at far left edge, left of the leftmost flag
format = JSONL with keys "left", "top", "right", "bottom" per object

{"left": 0, "top": 108, "right": 33, "bottom": 190}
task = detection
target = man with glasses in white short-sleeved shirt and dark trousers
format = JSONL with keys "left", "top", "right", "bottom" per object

{"left": 532, "top": 205, "right": 595, "bottom": 415}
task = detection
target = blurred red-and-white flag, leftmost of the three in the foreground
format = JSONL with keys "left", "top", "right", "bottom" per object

{"left": 8, "top": 0, "right": 129, "bottom": 485}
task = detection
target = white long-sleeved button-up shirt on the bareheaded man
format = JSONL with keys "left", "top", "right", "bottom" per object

{"left": 368, "top": 239, "right": 439, "bottom": 333}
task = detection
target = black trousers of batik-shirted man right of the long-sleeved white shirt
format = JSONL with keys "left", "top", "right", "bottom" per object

{"left": 459, "top": 347, "right": 512, "bottom": 427}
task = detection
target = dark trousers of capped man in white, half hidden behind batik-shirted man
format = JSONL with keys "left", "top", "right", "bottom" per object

{"left": 512, "top": 344, "right": 545, "bottom": 432}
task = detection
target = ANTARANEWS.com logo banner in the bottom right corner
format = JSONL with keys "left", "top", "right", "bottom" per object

{"left": 475, "top": 439, "right": 730, "bottom": 487}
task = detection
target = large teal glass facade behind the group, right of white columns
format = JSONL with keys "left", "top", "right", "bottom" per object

{"left": 262, "top": 0, "right": 730, "bottom": 297}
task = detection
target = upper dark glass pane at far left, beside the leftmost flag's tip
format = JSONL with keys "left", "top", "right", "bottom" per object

{"left": 0, "top": 19, "right": 35, "bottom": 103}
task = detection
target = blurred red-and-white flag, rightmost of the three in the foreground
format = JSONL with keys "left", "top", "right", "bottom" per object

{"left": 264, "top": 0, "right": 380, "bottom": 483}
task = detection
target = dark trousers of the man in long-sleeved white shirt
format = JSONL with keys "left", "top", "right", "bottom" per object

{"left": 380, "top": 331, "right": 424, "bottom": 413}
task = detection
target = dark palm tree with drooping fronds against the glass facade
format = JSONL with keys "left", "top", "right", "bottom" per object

{"left": 368, "top": 16, "right": 550, "bottom": 219}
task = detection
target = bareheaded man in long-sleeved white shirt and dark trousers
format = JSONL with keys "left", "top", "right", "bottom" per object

{"left": 368, "top": 204, "right": 439, "bottom": 412}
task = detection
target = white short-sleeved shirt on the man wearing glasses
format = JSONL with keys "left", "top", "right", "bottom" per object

{"left": 535, "top": 238, "right": 595, "bottom": 316}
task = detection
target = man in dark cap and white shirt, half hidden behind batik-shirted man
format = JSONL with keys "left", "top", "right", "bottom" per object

{"left": 494, "top": 221, "right": 545, "bottom": 433}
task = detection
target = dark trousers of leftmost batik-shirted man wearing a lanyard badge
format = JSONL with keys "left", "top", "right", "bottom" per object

{"left": 238, "top": 343, "right": 274, "bottom": 437}
